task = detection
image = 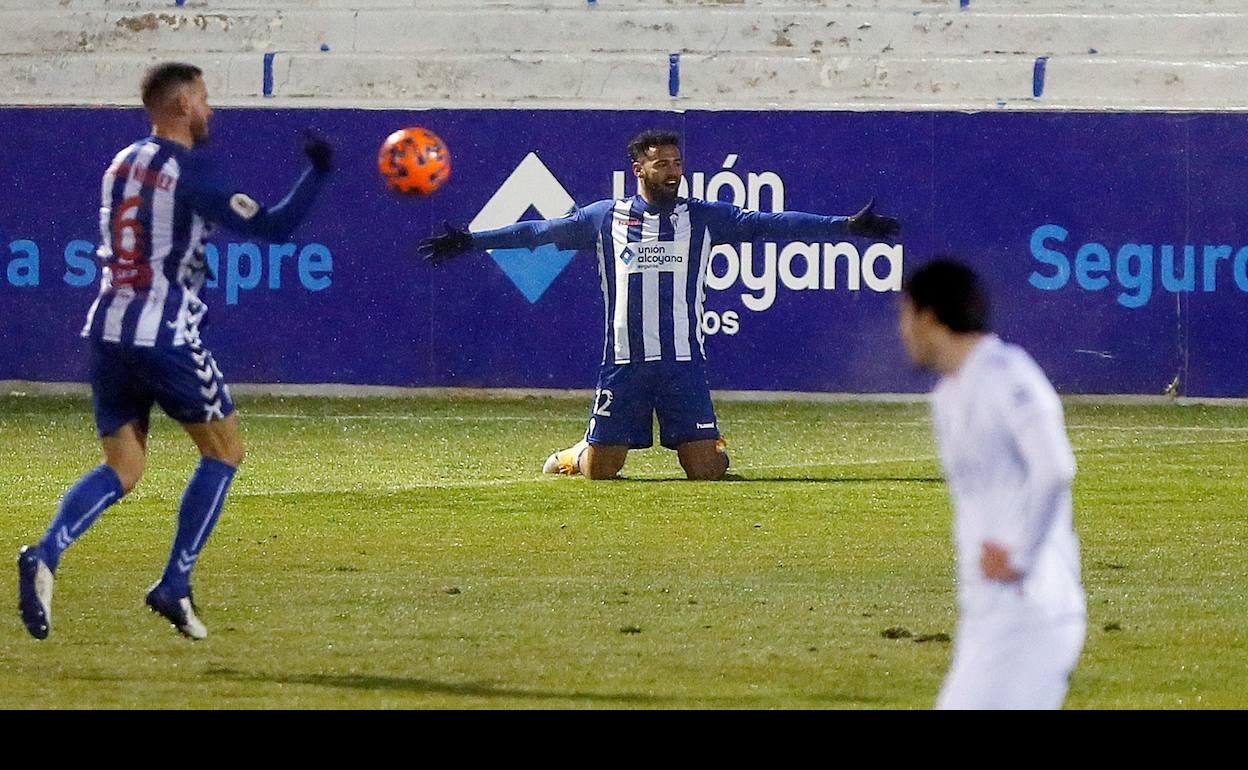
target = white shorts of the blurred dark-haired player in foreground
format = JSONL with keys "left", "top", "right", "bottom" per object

{"left": 936, "top": 618, "right": 1087, "bottom": 710}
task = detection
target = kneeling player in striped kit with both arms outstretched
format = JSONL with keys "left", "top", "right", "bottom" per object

{"left": 421, "top": 131, "right": 899, "bottom": 479}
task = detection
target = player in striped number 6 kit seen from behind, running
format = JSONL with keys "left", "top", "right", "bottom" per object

{"left": 17, "top": 62, "right": 332, "bottom": 639}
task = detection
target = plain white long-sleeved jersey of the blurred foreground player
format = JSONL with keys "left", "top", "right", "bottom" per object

{"left": 932, "top": 334, "right": 1086, "bottom": 620}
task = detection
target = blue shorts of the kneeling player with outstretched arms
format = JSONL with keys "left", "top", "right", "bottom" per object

{"left": 585, "top": 361, "right": 719, "bottom": 449}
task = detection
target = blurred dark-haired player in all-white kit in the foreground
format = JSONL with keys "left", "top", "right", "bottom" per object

{"left": 900, "top": 258, "right": 1087, "bottom": 709}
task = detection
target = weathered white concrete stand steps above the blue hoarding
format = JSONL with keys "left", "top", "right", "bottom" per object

{"left": 0, "top": 0, "right": 1248, "bottom": 110}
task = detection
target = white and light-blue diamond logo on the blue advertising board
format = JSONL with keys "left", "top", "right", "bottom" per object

{"left": 468, "top": 152, "right": 577, "bottom": 302}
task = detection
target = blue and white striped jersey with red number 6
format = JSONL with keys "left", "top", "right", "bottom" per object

{"left": 82, "top": 136, "right": 321, "bottom": 347}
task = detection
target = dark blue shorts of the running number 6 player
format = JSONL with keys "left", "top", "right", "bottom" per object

{"left": 90, "top": 339, "right": 235, "bottom": 438}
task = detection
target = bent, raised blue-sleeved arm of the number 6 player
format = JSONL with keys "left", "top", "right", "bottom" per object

{"left": 190, "top": 129, "right": 333, "bottom": 241}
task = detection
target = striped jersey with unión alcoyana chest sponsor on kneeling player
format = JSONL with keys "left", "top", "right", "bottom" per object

{"left": 472, "top": 195, "right": 846, "bottom": 364}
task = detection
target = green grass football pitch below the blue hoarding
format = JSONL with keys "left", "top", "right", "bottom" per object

{"left": 0, "top": 397, "right": 1248, "bottom": 709}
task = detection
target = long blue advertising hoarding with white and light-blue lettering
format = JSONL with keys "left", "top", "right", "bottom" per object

{"left": 0, "top": 109, "right": 1248, "bottom": 397}
